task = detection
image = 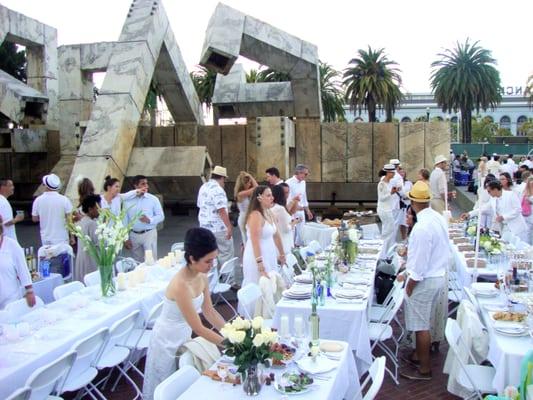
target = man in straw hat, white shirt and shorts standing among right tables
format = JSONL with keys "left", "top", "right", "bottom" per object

{"left": 400, "top": 181, "right": 450, "bottom": 380}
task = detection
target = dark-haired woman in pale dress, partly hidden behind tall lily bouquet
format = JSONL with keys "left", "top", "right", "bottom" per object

{"left": 74, "top": 194, "right": 100, "bottom": 282}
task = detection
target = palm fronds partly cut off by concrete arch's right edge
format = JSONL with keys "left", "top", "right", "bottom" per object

{"left": 319, "top": 61, "right": 345, "bottom": 122}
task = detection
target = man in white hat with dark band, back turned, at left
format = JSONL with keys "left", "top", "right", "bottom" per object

{"left": 31, "top": 174, "right": 72, "bottom": 246}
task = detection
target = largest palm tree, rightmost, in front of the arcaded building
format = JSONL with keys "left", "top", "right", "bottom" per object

{"left": 431, "top": 39, "right": 502, "bottom": 143}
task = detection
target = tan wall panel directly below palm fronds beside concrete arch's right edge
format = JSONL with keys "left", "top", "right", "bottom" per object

{"left": 322, "top": 122, "right": 347, "bottom": 182}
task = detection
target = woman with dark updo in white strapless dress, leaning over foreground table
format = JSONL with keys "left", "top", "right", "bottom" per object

{"left": 143, "top": 228, "right": 224, "bottom": 400}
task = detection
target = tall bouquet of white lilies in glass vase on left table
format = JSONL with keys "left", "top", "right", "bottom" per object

{"left": 67, "top": 208, "right": 138, "bottom": 297}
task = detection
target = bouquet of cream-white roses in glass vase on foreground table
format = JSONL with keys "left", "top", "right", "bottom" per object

{"left": 220, "top": 317, "right": 283, "bottom": 395}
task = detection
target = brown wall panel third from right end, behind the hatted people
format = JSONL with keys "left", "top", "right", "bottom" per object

{"left": 372, "top": 123, "right": 401, "bottom": 182}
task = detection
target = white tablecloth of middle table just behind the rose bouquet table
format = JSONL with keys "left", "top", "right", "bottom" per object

{"left": 273, "top": 240, "right": 381, "bottom": 374}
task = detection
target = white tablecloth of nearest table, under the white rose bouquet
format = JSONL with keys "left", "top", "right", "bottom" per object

{"left": 178, "top": 343, "right": 361, "bottom": 400}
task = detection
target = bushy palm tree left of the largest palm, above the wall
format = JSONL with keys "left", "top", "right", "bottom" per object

{"left": 343, "top": 46, "right": 403, "bottom": 122}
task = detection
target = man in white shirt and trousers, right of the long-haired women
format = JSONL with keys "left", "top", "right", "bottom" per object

{"left": 285, "top": 164, "right": 313, "bottom": 246}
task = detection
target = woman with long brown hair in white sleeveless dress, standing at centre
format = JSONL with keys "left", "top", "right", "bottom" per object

{"left": 242, "top": 185, "right": 285, "bottom": 286}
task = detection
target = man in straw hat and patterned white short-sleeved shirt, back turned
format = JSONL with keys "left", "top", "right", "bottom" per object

{"left": 196, "top": 165, "right": 236, "bottom": 280}
